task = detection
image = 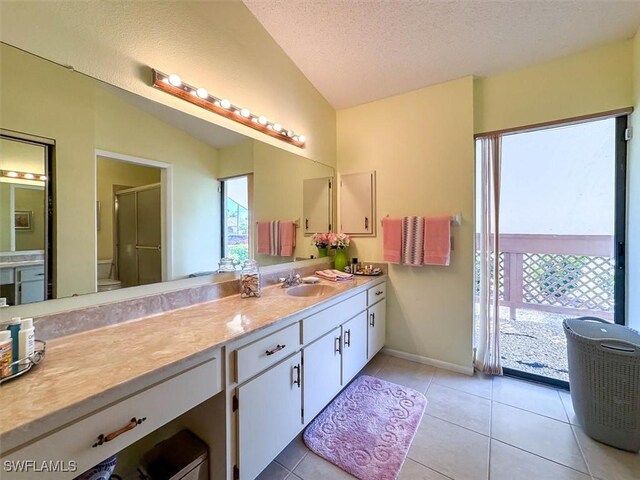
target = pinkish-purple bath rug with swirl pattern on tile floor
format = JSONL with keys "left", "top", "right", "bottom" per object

{"left": 303, "top": 375, "right": 427, "bottom": 480}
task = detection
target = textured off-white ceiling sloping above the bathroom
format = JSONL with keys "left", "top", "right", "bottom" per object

{"left": 243, "top": 0, "right": 640, "bottom": 109}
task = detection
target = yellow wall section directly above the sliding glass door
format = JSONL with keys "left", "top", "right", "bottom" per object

{"left": 474, "top": 40, "right": 633, "bottom": 133}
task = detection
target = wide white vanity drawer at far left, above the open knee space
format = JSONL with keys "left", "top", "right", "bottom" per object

{"left": 2, "top": 355, "right": 222, "bottom": 480}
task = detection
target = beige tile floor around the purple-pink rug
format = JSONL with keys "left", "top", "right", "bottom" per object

{"left": 258, "top": 354, "right": 640, "bottom": 480}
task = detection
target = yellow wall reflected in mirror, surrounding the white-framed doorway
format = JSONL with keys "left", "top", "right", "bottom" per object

{"left": 0, "top": 45, "right": 220, "bottom": 297}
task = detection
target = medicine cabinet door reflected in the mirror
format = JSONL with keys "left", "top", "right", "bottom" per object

{"left": 302, "top": 177, "right": 333, "bottom": 234}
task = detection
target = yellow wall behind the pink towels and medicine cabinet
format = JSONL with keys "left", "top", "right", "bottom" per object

{"left": 337, "top": 77, "right": 474, "bottom": 368}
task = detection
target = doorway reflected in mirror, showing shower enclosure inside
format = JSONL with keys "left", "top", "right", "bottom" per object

{"left": 96, "top": 151, "right": 171, "bottom": 291}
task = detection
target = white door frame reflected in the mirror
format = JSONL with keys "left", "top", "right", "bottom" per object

{"left": 94, "top": 149, "right": 173, "bottom": 282}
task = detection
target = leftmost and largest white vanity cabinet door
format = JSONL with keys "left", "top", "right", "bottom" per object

{"left": 237, "top": 352, "right": 302, "bottom": 480}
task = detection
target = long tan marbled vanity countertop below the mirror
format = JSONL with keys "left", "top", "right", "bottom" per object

{"left": 0, "top": 277, "right": 383, "bottom": 453}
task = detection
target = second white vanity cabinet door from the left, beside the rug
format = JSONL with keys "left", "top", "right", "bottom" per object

{"left": 303, "top": 327, "right": 342, "bottom": 424}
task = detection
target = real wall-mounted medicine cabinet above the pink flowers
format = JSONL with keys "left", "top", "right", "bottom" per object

{"left": 340, "top": 172, "right": 375, "bottom": 235}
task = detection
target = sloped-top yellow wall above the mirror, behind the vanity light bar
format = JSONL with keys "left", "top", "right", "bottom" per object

{"left": 0, "top": 0, "right": 336, "bottom": 165}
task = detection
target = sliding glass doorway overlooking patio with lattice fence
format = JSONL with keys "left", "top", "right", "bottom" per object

{"left": 476, "top": 116, "right": 627, "bottom": 387}
